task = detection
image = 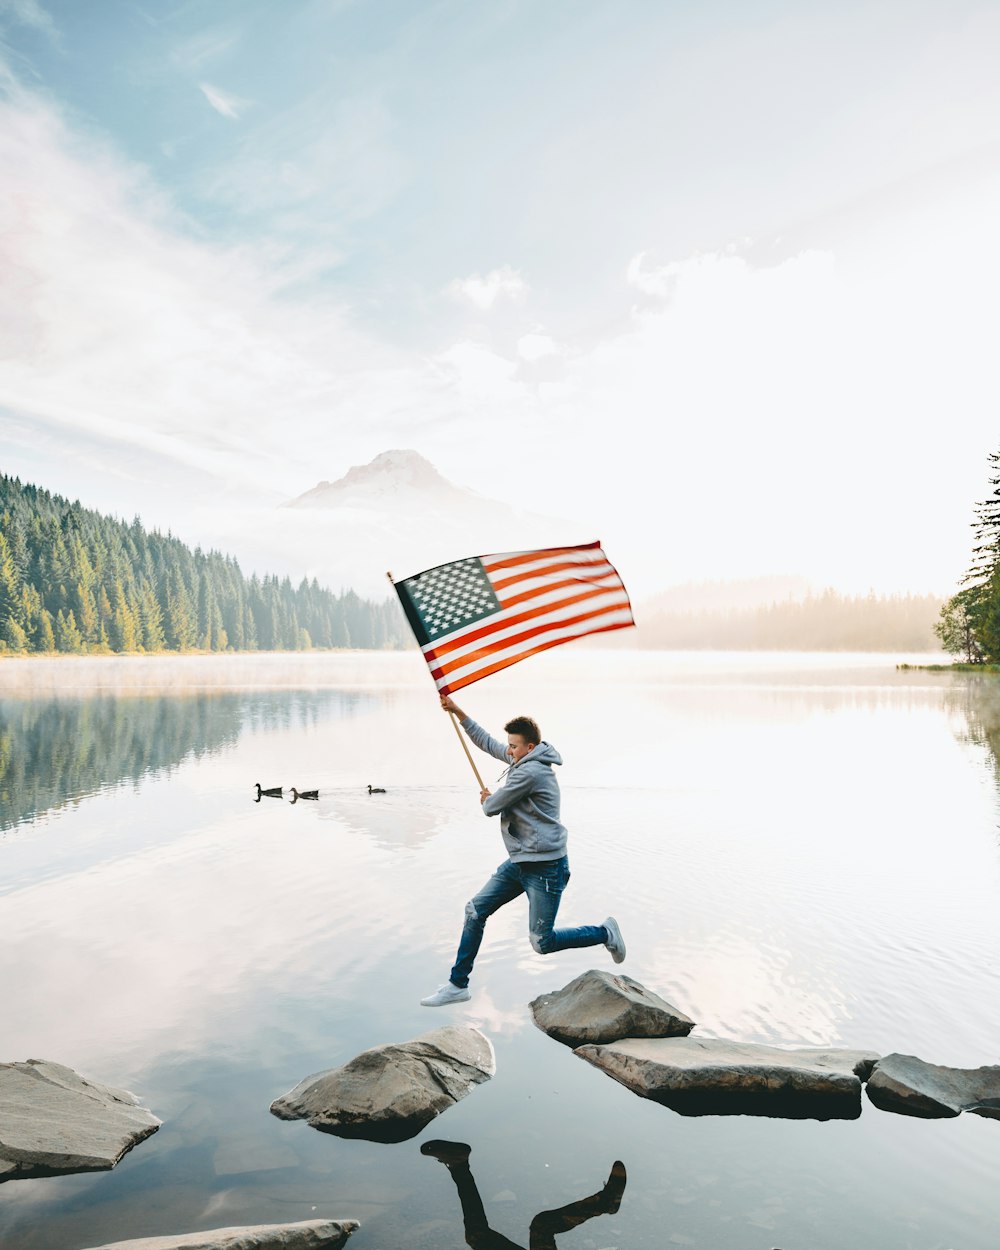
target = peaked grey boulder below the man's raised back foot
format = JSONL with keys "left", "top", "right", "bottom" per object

{"left": 531, "top": 968, "right": 695, "bottom": 1046}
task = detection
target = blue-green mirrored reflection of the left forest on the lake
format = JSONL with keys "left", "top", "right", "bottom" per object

{"left": 0, "top": 691, "right": 356, "bottom": 829}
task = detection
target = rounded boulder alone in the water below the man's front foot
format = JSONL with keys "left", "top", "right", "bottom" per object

{"left": 271, "top": 1025, "right": 496, "bottom": 1141}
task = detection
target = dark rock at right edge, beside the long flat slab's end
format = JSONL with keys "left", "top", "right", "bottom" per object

{"left": 868, "top": 1055, "right": 1000, "bottom": 1120}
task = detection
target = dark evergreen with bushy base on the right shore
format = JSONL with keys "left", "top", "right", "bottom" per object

{"left": 935, "top": 453, "right": 1000, "bottom": 664}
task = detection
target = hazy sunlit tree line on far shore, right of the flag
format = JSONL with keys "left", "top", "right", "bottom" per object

{"left": 634, "top": 590, "right": 941, "bottom": 651}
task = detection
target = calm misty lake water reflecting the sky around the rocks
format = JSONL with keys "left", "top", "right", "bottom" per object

{"left": 0, "top": 648, "right": 1000, "bottom": 1250}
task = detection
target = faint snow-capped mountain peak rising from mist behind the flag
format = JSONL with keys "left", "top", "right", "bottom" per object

{"left": 221, "top": 450, "right": 577, "bottom": 599}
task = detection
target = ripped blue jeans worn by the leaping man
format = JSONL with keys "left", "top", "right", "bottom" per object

{"left": 449, "top": 855, "right": 608, "bottom": 989}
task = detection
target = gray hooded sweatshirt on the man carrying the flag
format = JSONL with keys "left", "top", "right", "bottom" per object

{"left": 461, "top": 716, "right": 566, "bottom": 864}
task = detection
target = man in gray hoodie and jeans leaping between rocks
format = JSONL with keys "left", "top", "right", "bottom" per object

{"left": 420, "top": 695, "right": 625, "bottom": 1008}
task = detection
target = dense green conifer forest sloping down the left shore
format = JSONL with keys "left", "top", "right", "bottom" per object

{"left": 0, "top": 476, "right": 411, "bottom": 654}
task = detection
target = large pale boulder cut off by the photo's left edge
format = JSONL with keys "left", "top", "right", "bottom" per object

{"left": 0, "top": 1059, "right": 161, "bottom": 1181}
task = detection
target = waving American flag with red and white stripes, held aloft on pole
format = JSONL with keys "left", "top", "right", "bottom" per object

{"left": 394, "top": 543, "right": 635, "bottom": 695}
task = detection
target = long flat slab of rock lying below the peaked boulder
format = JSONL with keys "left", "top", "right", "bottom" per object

{"left": 575, "top": 1038, "right": 879, "bottom": 1120}
